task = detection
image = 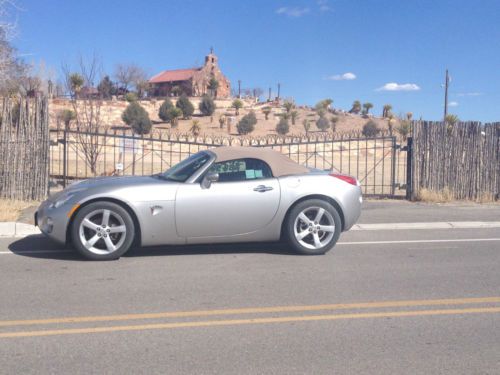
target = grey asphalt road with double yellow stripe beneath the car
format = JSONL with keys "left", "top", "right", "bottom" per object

{"left": 0, "top": 206, "right": 500, "bottom": 374}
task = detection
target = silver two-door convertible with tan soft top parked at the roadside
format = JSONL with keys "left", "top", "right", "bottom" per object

{"left": 35, "top": 147, "right": 362, "bottom": 260}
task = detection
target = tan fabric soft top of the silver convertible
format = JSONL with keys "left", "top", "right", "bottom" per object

{"left": 210, "top": 146, "right": 309, "bottom": 177}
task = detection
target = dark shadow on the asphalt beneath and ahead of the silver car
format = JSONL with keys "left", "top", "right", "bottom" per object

{"left": 8, "top": 235, "right": 296, "bottom": 261}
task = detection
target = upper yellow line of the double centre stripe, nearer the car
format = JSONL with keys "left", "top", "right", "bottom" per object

{"left": 0, "top": 297, "right": 500, "bottom": 327}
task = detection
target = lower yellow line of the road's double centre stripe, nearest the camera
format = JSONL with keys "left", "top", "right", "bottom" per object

{"left": 0, "top": 307, "right": 500, "bottom": 338}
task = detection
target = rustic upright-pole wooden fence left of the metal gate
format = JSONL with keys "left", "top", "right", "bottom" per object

{"left": 0, "top": 97, "right": 49, "bottom": 200}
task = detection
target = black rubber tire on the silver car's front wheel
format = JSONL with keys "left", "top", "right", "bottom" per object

{"left": 71, "top": 201, "right": 135, "bottom": 260}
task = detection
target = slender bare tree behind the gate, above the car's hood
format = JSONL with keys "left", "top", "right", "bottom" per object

{"left": 62, "top": 55, "right": 104, "bottom": 174}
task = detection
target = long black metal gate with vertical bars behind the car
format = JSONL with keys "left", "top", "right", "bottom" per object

{"left": 50, "top": 129, "right": 407, "bottom": 197}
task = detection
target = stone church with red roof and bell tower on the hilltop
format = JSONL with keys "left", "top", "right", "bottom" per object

{"left": 149, "top": 49, "right": 231, "bottom": 98}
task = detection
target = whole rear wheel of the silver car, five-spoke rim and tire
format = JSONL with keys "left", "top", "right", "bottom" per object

{"left": 286, "top": 199, "right": 342, "bottom": 255}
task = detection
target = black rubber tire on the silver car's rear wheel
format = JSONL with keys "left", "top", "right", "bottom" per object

{"left": 284, "top": 199, "right": 342, "bottom": 255}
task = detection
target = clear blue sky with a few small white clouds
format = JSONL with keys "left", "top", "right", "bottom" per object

{"left": 13, "top": 0, "right": 500, "bottom": 121}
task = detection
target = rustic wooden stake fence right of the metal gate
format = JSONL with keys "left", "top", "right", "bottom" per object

{"left": 411, "top": 121, "right": 500, "bottom": 201}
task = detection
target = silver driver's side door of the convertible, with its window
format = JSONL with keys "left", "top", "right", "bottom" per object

{"left": 175, "top": 159, "right": 280, "bottom": 238}
